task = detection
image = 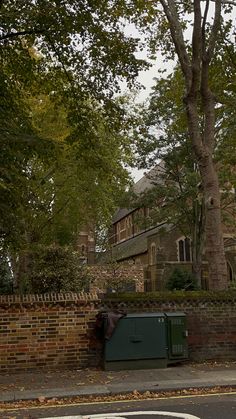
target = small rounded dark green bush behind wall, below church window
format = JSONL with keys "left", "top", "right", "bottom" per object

{"left": 166, "top": 268, "right": 198, "bottom": 291}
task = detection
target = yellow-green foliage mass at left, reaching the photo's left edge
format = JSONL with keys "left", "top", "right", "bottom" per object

{"left": 0, "top": 73, "right": 134, "bottom": 290}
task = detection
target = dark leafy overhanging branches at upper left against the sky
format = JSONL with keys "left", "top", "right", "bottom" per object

{"left": 0, "top": 0, "right": 147, "bottom": 108}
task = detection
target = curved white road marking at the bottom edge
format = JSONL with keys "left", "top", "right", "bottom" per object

{"left": 42, "top": 410, "right": 201, "bottom": 419}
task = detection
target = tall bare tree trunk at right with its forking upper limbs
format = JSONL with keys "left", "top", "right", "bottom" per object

{"left": 160, "top": 0, "right": 227, "bottom": 290}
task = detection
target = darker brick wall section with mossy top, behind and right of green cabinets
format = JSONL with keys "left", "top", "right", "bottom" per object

{"left": 106, "top": 293, "right": 236, "bottom": 361}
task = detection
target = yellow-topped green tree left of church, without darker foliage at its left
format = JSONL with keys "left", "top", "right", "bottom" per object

{"left": 3, "top": 90, "right": 133, "bottom": 289}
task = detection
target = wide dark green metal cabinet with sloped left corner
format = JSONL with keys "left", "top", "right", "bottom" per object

{"left": 104, "top": 313, "right": 167, "bottom": 370}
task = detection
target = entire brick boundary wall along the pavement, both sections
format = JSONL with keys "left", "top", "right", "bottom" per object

{"left": 0, "top": 293, "right": 236, "bottom": 372}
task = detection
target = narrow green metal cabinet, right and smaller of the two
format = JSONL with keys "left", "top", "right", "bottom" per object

{"left": 165, "top": 312, "right": 188, "bottom": 364}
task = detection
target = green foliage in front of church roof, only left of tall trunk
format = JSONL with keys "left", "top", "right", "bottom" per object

{"left": 134, "top": 67, "right": 202, "bottom": 237}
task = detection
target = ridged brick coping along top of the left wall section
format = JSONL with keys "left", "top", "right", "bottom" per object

{"left": 0, "top": 292, "right": 99, "bottom": 305}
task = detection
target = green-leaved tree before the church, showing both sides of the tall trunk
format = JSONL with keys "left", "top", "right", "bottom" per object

{"left": 135, "top": 50, "right": 236, "bottom": 284}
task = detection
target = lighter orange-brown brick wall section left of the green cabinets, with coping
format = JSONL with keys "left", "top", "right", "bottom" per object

{"left": 0, "top": 294, "right": 98, "bottom": 371}
